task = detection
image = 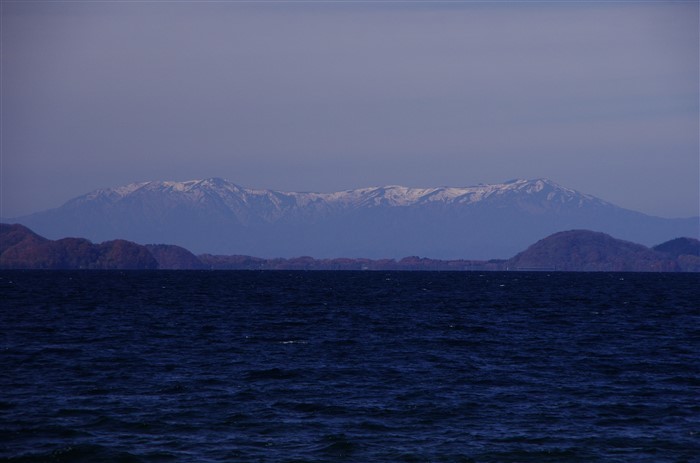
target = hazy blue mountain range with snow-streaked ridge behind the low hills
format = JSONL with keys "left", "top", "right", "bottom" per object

{"left": 10, "top": 178, "right": 700, "bottom": 259}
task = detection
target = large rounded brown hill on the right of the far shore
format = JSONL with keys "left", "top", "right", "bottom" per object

{"left": 508, "top": 230, "right": 682, "bottom": 272}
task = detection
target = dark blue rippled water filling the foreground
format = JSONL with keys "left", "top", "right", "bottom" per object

{"left": 0, "top": 271, "right": 700, "bottom": 462}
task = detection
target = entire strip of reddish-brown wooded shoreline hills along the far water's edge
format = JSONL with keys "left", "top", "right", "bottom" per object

{"left": 0, "top": 224, "right": 700, "bottom": 272}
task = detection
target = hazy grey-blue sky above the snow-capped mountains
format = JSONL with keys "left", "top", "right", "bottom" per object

{"left": 0, "top": 0, "right": 700, "bottom": 218}
